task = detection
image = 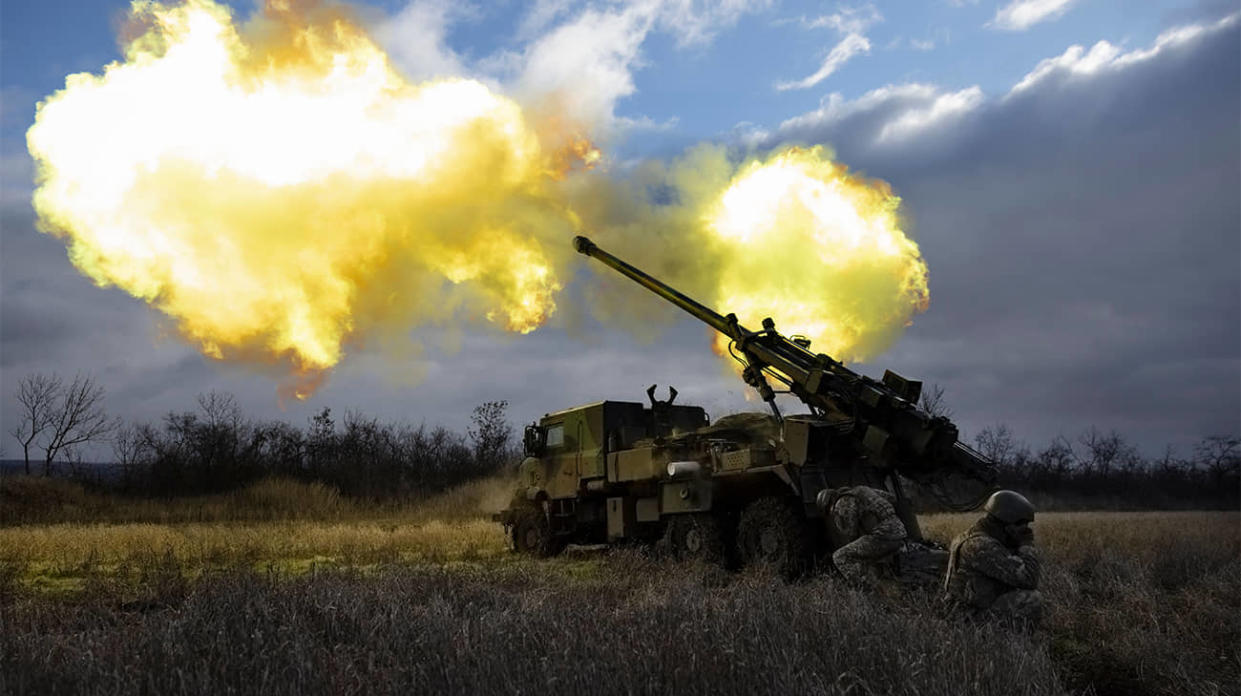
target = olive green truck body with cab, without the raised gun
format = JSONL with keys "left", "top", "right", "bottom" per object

{"left": 494, "top": 401, "right": 917, "bottom": 565}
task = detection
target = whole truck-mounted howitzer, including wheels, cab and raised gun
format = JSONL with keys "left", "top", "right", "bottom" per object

{"left": 493, "top": 237, "right": 992, "bottom": 576}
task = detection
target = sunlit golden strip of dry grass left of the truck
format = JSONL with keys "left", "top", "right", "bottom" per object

{"left": 0, "top": 478, "right": 511, "bottom": 600}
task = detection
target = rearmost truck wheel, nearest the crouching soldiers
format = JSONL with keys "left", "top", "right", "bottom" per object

{"left": 737, "top": 496, "right": 813, "bottom": 578}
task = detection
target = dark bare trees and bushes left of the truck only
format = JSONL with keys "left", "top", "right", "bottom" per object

{"left": 10, "top": 375, "right": 519, "bottom": 499}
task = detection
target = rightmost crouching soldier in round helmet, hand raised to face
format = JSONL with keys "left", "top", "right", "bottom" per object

{"left": 943, "top": 490, "right": 1042, "bottom": 628}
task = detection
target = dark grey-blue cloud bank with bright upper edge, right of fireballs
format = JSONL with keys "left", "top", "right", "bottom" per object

{"left": 766, "top": 20, "right": 1241, "bottom": 452}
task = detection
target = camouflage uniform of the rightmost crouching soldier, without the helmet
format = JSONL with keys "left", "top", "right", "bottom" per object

{"left": 943, "top": 517, "right": 1042, "bottom": 627}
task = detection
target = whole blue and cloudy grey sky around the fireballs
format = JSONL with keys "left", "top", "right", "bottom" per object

{"left": 0, "top": 0, "right": 1241, "bottom": 457}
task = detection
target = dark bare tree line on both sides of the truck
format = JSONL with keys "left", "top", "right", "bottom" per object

{"left": 10, "top": 373, "right": 1241, "bottom": 509}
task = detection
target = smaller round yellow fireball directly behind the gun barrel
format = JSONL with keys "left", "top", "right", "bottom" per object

{"left": 705, "top": 148, "right": 930, "bottom": 361}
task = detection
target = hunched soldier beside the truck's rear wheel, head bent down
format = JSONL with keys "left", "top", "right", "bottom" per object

{"left": 815, "top": 486, "right": 907, "bottom": 584}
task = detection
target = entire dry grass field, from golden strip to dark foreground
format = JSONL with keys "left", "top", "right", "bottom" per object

{"left": 0, "top": 481, "right": 1241, "bottom": 695}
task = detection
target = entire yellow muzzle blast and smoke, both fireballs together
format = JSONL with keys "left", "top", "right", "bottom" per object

{"left": 27, "top": 0, "right": 927, "bottom": 397}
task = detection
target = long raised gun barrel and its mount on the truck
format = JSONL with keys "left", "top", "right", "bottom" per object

{"left": 573, "top": 237, "right": 993, "bottom": 491}
